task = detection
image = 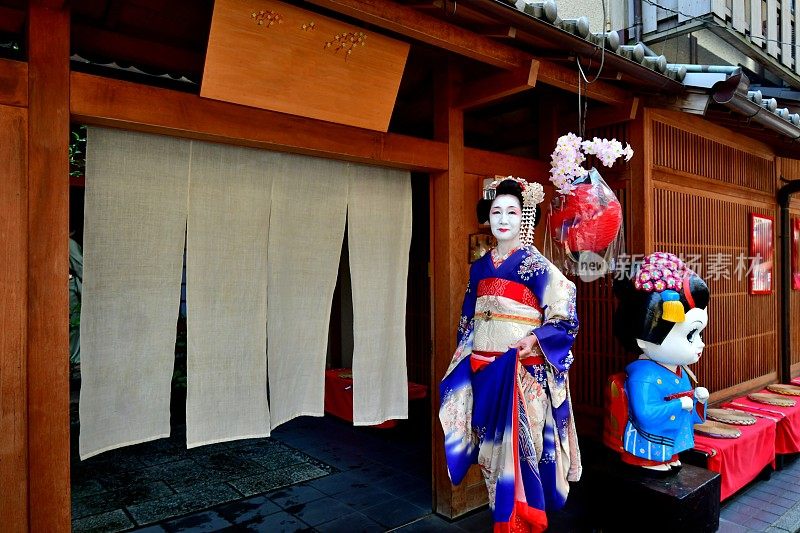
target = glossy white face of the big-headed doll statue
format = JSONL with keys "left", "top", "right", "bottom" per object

{"left": 636, "top": 308, "right": 708, "bottom": 365}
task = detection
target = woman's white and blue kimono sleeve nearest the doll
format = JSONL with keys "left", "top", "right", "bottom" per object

{"left": 531, "top": 261, "right": 578, "bottom": 374}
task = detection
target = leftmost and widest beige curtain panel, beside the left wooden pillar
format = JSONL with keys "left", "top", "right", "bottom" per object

{"left": 79, "top": 127, "right": 190, "bottom": 459}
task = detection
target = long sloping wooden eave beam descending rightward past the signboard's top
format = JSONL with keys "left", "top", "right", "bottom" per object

{"left": 306, "top": 0, "right": 631, "bottom": 104}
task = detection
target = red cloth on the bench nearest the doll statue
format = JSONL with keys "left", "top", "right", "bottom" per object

{"left": 694, "top": 418, "right": 775, "bottom": 500}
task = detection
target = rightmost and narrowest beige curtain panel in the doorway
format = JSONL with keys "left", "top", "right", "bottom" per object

{"left": 347, "top": 165, "right": 411, "bottom": 425}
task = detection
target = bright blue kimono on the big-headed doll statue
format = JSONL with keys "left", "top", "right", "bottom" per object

{"left": 623, "top": 359, "right": 705, "bottom": 462}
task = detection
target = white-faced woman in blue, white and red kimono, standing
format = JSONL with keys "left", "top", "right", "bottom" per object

{"left": 439, "top": 179, "right": 581, "bottom": 531}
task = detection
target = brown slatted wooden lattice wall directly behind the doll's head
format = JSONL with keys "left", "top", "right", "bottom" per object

{"left": 653, "top": 188, "right": 778, "bottom": 392}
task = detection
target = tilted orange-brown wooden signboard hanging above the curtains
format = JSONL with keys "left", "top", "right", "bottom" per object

{"left": 200, "top": 0, "right": 409, "bottom": 132}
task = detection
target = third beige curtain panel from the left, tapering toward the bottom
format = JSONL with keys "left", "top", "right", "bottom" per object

{"left": 267, "top": 155, "right": 349, "bottom": 428}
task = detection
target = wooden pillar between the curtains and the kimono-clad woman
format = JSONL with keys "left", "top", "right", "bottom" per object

{"left": 431, "top": 60, "right": 476, "bottom": 517}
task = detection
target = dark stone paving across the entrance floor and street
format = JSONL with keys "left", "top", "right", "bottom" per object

{"left": 72, "top": 417, "right": 800, "bottom": 533}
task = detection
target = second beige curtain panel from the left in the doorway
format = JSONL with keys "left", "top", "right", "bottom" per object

{"left": 186, "top": 141, "right": 281, "bottom": 448}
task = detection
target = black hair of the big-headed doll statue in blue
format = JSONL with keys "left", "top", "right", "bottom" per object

{"left": 614, "top": 272, "right": 710, "bottom": 354}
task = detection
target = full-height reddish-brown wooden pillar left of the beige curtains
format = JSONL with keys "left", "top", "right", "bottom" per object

{"left": 27, "top": 0, "right": 71, "bottom": 532}
